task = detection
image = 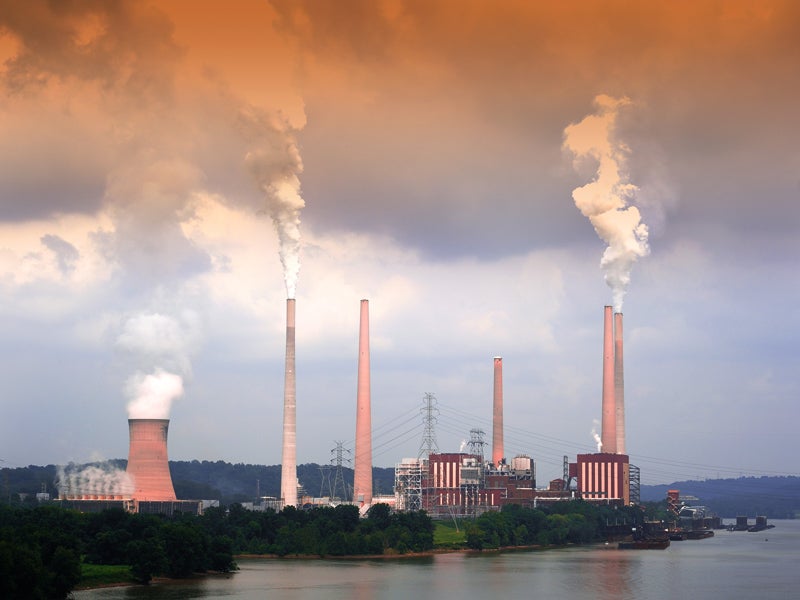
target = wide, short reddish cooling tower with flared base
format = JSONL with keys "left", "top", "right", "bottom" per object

{"left": 127, "top": 419, "right": 176, "bottom": 501}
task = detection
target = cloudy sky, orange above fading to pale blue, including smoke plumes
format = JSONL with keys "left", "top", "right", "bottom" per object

{"left": 0, "top": 0, "right": 800, "bottom": 484}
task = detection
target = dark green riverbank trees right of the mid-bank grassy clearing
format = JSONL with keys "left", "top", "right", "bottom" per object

{"left": 466, "top": 501, "right": 645, "bottom": 550}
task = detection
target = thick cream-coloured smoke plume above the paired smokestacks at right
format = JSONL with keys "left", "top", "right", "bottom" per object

{"left": 564, "top": 95, "right": 650, "bottom": 312}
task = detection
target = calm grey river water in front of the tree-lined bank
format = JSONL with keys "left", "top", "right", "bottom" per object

{"left": 73, "top": 520, "right": 800, "bottom": 600}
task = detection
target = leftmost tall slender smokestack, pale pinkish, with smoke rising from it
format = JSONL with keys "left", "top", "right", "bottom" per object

{"left": 281, "top": 298, "right": 297, "bottom": 506}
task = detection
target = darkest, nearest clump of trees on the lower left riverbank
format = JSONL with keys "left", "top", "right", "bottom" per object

{"left": 0, "top": 505, "right": 235, "bottom": 599}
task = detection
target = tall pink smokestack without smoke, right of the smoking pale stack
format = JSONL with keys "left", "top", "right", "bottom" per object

{"left": 353, "top": 300, "right": 372, "bottom": 506}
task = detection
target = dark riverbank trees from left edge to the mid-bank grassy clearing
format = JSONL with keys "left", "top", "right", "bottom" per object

{"left": 0, "top": 504, "right": 433, "bottom": 598}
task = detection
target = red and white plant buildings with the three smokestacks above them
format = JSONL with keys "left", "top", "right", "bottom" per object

{"left": 395, "top": 306, "right": 639, "bottom": 517}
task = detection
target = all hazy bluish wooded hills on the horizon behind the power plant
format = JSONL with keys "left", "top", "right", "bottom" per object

{"left": 2, "top": 459, "right": 800, "bottom": 519}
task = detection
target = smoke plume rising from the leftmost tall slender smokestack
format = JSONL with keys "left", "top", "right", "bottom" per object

{"left": 240, "top": 109, "right": 305, "bottom": 298}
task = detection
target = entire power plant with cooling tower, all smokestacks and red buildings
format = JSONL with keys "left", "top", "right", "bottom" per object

{"left": 53, "top": 298, "right": 638, "bottom": 517}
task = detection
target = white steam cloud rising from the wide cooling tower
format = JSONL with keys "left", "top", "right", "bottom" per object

{"left": 117, "top": 312, "right": 197, "bottom": 419}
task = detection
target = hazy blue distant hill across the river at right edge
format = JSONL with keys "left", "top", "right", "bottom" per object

{"left": 641, "top": 477, "right": 800, "bottom": 519}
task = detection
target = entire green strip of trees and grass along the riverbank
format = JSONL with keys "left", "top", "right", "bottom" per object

{"left": 0, "top": 501, "right": 661, "bottom": 598}
